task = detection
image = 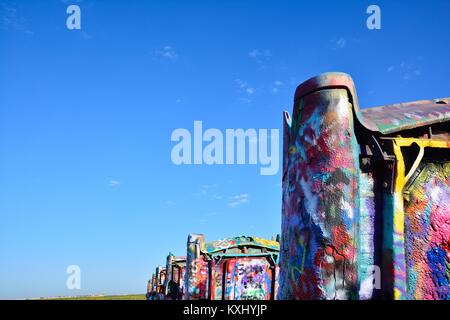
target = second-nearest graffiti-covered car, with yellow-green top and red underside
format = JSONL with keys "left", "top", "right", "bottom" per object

{"left": 184, "top": 234, "right": 280, "bottom": 300}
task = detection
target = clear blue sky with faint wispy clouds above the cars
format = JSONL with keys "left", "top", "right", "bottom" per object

{"left": 0, "top": 0, "right": 450, "bottom": 298}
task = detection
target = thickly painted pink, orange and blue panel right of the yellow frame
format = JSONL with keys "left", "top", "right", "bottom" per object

{"left": 405, "top": 162, "right": 450, "bottom": 300}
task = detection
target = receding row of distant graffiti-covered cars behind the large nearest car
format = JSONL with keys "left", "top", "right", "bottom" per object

{"left": 147, "top": 234, "right": 280, "bottom": 300}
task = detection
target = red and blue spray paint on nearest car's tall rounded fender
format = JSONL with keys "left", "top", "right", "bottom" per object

{"left": 280, "top": 81, "right": 358, "bottom": 299}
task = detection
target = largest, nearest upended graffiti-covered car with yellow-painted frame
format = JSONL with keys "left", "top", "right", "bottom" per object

{"left": 278, "top": 73, "right": 450, "bottom": 299}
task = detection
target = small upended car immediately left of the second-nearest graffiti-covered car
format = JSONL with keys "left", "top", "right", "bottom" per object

{"left": 164, "top": 253, "right": 186, "bottom": 300}
